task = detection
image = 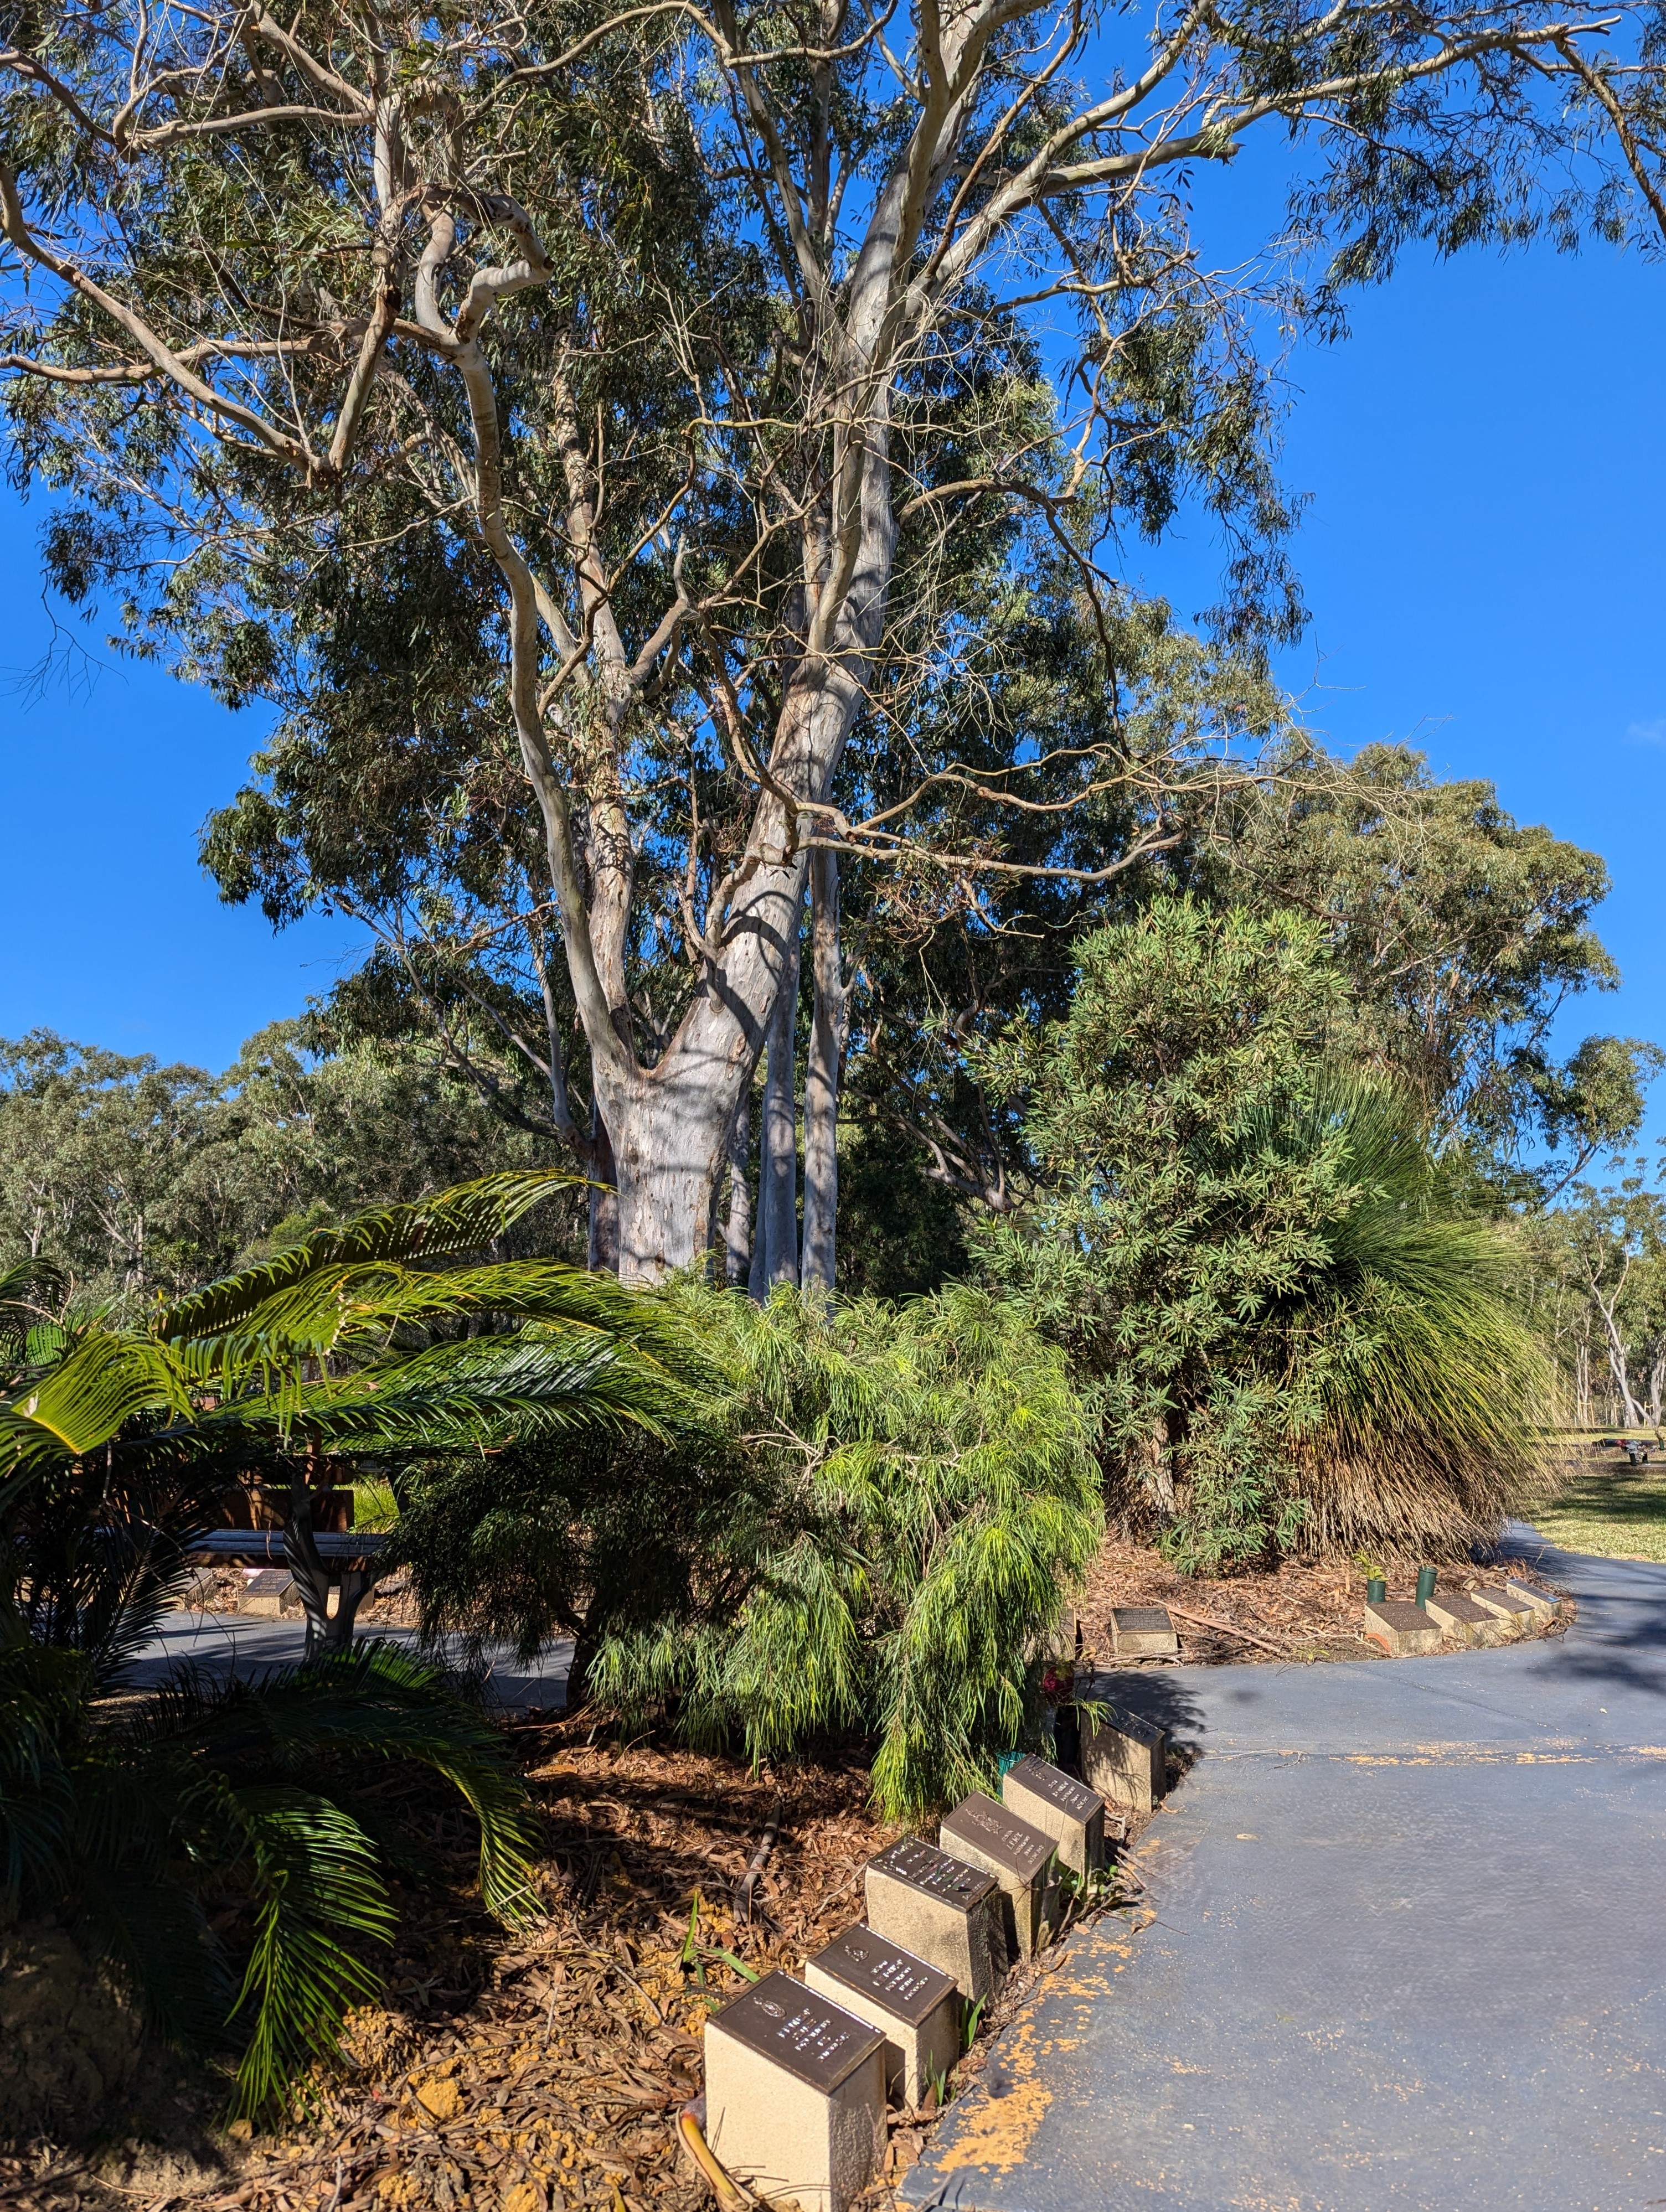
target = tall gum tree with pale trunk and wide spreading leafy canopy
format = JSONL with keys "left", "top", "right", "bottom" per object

{"left": 0, "top": 0, "right": 1648, "bottom": 1279}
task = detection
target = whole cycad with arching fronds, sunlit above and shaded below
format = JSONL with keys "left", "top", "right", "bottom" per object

{"left": 0, "top": 1175, "right": 677, "bottom": 2112}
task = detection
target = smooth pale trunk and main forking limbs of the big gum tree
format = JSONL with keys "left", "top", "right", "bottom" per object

{"left": 416, "top": 151, "right": 898, "bottom": 1283}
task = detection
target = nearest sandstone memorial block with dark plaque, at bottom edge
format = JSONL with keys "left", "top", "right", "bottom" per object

{"left": 706, "top": 1973, "right": 885, "bottom": 2212}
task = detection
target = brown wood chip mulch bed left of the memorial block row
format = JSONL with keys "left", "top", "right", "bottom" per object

{"left": 0, "top": 1719, "right": 1141, "bottom": 2212}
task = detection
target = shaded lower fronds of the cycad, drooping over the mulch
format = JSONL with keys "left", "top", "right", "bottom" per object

{"left": 0, "top": 1615, "right": 535, "bottom": 2115}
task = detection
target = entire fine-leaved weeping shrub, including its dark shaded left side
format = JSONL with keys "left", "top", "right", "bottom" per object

{"left": 398, "top": 1283, "right": 1102, "bottom": 1818}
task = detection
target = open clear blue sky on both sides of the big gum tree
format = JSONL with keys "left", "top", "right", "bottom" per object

{"left": 0, "top": 224, "right": 1666, "bottom": 1097}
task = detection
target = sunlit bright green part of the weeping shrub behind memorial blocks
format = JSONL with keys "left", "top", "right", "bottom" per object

{"left": 593, "top": 1285, "right": 1102, "bottom": 1818}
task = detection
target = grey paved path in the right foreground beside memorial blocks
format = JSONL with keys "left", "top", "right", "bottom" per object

{"left": 905, "top": 1526, "right": 1666, "bottom": 2212}
